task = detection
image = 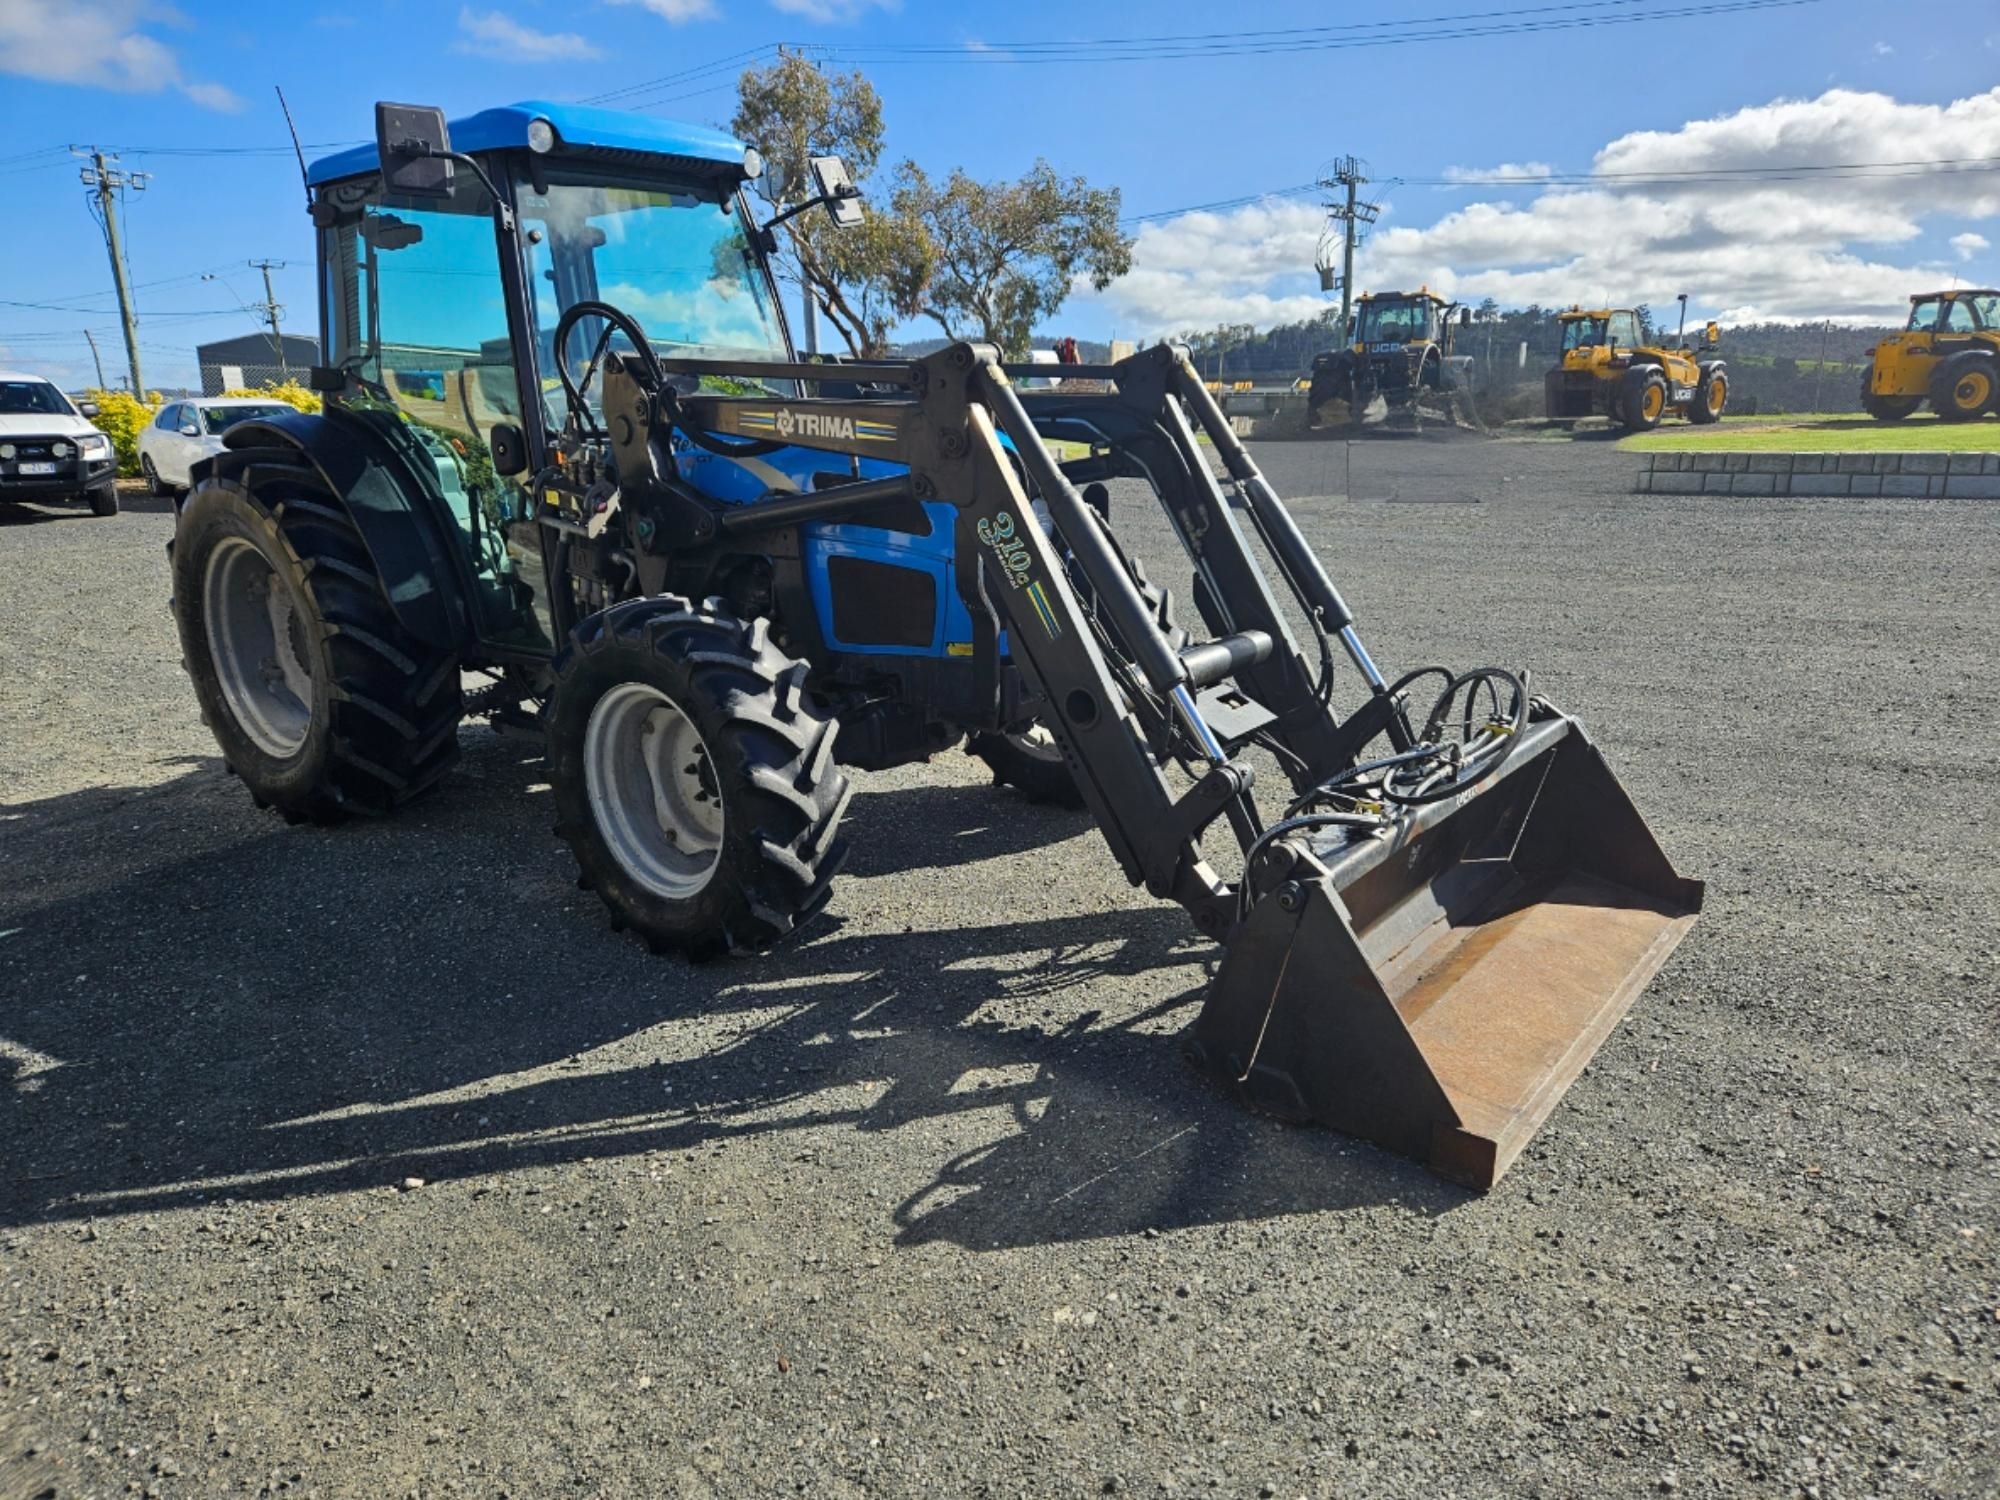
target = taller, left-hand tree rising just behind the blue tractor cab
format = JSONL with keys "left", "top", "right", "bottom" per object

{"left": 730, "top": 52, "right": 900, "bottom": 354}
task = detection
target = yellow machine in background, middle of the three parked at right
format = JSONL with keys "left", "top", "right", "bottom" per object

{"left": 1542, "top": 308, "right": 1730, "bottom": 432}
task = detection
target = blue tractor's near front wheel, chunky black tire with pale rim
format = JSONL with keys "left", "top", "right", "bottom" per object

{"left": 548, "top": 596, "right": 850, "bottom": 960}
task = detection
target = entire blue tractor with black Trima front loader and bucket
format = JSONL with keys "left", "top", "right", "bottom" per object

{"left": 172, "top": 104, "right": 1702, "bottom": 1188}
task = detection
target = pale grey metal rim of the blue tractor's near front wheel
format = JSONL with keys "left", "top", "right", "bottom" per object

{"left": 584, "top": 682, "right": 724, "bottom": 900}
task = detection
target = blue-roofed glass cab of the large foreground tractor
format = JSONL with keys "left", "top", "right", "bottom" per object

{"left": 296, "top": 102, "right": 856, "bottom": 656}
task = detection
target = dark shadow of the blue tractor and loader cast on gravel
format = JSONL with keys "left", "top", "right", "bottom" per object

{"left": 0, "top": 734, "right": 1466, "bottom": 1248}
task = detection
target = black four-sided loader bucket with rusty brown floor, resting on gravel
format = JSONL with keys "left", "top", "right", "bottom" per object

{"left": 1186, "top": 718, "right": 1702, "bottom": 1190}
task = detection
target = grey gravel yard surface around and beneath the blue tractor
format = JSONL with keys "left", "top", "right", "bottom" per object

{"left": 0, "top": 442, "right": 2000, "bottom": 1500}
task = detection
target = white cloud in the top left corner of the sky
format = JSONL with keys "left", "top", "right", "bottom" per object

{"left": 0, "top": 0, "right": 244, "bottom": 110}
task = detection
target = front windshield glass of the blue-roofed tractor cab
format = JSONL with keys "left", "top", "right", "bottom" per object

{"left": 520, "top": 180, "right": 792, "bottom": 400}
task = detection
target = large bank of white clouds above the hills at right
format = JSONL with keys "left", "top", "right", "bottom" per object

{"left": 1076, "top": 88, "right": 2000, "bottom": 334}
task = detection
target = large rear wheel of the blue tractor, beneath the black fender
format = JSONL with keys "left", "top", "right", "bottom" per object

{"left": 172, "top": 468, "right": 464, "bottom": 824}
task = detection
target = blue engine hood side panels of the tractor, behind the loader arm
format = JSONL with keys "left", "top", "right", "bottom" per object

{"left": 676, "top": 448, "right": 984, "bottom": 656}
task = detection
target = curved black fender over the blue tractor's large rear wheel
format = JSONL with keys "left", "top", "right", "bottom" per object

{"left": 192, "top": 410, "right": 472, "bottom": 650}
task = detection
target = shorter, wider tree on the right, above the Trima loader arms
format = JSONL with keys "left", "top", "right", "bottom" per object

{"left": 890, "top": 162, "right": 1132, "bottom": 358}
